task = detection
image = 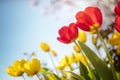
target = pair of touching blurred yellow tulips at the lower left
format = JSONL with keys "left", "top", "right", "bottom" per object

{"left": 6, "top": 58, "right": 41, "bottom": 77}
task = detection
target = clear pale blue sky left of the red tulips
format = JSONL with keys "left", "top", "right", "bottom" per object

{"left": 0, "top": 0, "right": 77, "bottom": 80}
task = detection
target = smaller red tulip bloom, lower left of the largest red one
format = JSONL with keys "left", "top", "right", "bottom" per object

{"left": 57, "top": 23, "right": 78, "bottom": 44}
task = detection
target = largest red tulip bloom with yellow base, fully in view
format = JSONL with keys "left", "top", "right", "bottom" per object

{"left": 75, "top": 7, "right": 102, "bottom": 32}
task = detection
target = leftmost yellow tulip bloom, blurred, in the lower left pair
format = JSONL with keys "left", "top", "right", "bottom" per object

{"left": 6, "top": 59, "right": 26, "bottom": 77}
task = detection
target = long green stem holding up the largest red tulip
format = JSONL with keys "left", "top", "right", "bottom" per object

{"left": 97, "top": 30, "right": 117, "bottom": 80}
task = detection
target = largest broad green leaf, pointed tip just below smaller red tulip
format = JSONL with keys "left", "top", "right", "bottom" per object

{"left": 79, "top": 42, "right": 114, "bottom": 80}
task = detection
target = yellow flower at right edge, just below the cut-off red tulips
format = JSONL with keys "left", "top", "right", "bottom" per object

{"left": 108, "top": 32, "right": 120, "bottom": 46}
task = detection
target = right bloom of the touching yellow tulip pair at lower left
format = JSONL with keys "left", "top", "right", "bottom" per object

{"left": 23, "top": 58, "right": 41, "bottom": 76}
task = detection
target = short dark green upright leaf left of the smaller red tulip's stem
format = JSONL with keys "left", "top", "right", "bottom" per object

{"left": 79, "top": 62, "right": 91, "bottom": 80}
